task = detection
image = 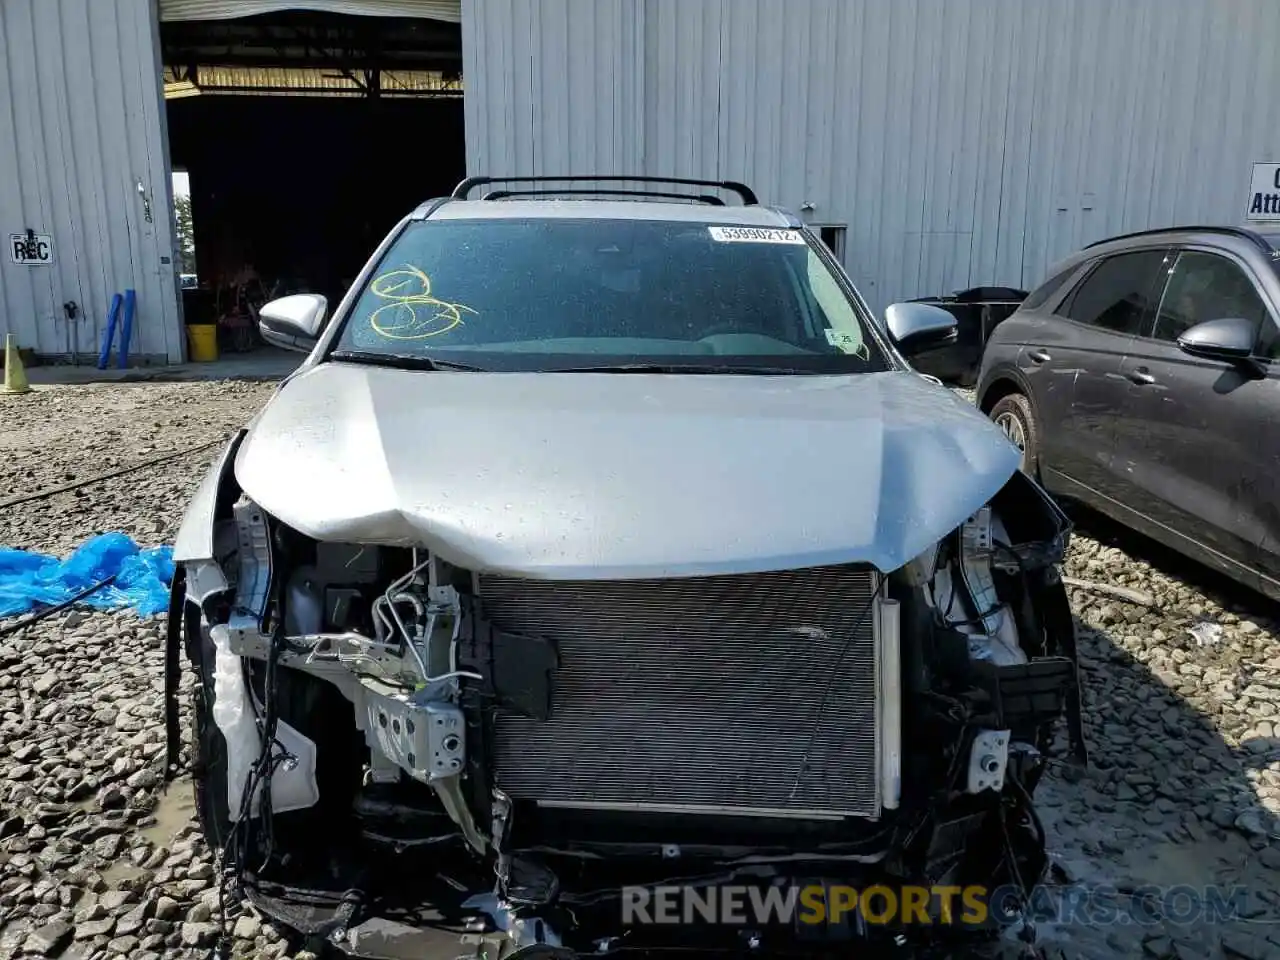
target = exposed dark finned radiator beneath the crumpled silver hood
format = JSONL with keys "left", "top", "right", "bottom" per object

{"left": 480, "top": 566, "right": 881, "bottom": 817}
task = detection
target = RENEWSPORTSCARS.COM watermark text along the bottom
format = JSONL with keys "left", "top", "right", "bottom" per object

{"left": 621, "top": 884, "right": 1248, "bottom": 927}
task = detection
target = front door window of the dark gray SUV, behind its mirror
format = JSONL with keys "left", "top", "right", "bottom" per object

{"left": 1151, "top": 250, "right": 1274, "bottom": 349}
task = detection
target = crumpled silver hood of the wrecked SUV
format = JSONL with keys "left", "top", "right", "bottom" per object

{"left": 236, "top": 362, "right": 1019, "bottom": 579}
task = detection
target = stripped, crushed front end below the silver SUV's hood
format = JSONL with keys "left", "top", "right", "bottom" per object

{"left": 170, "top": 450, "right": 1085, "bottom": 957}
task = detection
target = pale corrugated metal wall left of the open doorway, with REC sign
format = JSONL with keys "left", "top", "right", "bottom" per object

{"left": 0, "top": 0, "right": 184, "bottom": 364}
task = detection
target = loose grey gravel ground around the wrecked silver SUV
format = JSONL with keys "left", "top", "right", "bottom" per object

{"left": 0, "top": 383, "right": 1280, "bottom": 960}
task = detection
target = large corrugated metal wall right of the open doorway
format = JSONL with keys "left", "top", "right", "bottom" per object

{"left": 462, "top": 0, "right": 1280, "bottom": 307}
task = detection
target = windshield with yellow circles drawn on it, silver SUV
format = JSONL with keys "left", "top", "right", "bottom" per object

{"left": 333, "top": 218, "right": 890, "bottom": 372}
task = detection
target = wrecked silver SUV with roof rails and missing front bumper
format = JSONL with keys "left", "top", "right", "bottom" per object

{"left": 168, "top": 178, "right": 1084, "bottom": 957}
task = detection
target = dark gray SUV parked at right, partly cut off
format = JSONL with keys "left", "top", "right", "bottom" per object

{"left": 978, "top": 227, "right": 1280, "bottom": 599}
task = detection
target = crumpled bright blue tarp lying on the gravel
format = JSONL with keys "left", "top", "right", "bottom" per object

{"left": 0, "top": 532, "right": 173, "bottom": 617}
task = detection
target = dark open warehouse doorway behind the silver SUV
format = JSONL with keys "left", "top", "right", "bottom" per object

{"left": 160, "top": 0, "right": 466, "bottom": 353}
